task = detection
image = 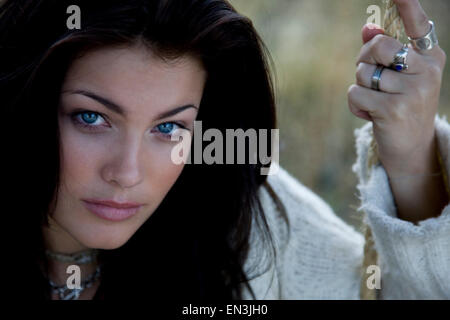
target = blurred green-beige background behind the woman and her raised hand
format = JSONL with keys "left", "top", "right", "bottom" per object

{"left": 230, "top": 0, "right": 450, "bottom": 230}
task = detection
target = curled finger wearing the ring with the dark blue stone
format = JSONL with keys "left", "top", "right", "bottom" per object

{"left": 356, "top": 35, "right": 427, "bottom": 74}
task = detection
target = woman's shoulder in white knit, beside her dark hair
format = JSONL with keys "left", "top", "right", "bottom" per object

{"left": 248, "top": 168, "right": 364, "bottom": 299}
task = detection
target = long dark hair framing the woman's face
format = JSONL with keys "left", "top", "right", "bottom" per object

{"left": 0, "top": 0, "right": 288, "bottom": 300}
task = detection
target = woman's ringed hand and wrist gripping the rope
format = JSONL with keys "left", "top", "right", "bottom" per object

{"left": 348, "top": 0, "right": 447, "bottom": 221}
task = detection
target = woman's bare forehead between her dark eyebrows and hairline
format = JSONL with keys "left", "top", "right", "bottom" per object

{"left": 63, "top": 45, "right": 206, "bottom": 114}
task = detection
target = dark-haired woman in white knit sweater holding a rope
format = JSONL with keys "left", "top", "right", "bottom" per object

{"left": 0, "top": 0, "right": 450, "bottom": 300}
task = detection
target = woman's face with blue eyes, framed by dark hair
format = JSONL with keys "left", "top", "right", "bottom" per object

{"left": 52, "top": 46, "right": 206, "bottom": 249}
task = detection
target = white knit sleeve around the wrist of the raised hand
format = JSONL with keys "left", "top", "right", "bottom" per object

{"left": 353, "top": 115, "right": 450, "bottom": 299}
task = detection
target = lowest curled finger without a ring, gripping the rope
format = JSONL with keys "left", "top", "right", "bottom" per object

{"left": 348, "top": 85, "right": 396, "bottom": 119}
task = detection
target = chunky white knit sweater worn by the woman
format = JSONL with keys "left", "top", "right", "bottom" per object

{"left": 243, "top": 116, "right": 450, "bottom": 299}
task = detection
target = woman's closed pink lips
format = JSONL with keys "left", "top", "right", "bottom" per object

{"left": 83, "top": 199, "right": 142, "bottom": 221}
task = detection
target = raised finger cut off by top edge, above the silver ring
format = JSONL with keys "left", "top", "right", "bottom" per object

{"left": 394, "top": 0, "right": 430, "bottom": 38}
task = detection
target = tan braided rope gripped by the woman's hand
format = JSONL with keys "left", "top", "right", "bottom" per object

{"left": 360, "top": 0, "right": 404, "bottom": 300}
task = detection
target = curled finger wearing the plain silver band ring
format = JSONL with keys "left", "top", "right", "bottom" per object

{"left": 356, "top": 62, "right": 413, "bottom": 93}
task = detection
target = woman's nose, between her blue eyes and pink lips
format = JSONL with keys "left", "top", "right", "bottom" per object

{"left": 101, "top": 139, "right": 142, "bottom": 189}
